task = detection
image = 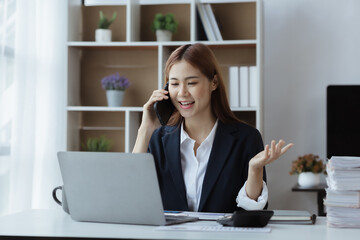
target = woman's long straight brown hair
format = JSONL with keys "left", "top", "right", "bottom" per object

{"left": 165, "top": 43, "right": 240, "bottom": 126}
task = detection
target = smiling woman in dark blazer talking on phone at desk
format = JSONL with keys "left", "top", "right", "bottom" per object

{"left": 133, "top": 43, "right": 292, "bottom": 212}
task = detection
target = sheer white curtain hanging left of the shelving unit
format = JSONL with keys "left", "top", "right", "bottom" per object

{"left": 7, "top": 0, "right": 67, "bottom": 213}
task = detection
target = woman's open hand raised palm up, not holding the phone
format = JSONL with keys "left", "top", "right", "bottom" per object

{"left": 249, "top": 140, "right": 294, "bottom": 170}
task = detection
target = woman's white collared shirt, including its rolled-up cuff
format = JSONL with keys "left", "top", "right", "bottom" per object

{"left": 180, "top": 120, "right": 268, "bottom": 211}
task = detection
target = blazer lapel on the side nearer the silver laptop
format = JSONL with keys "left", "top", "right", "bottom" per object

{"left": 162, "top": 127, "right": 188, "bottom": 208}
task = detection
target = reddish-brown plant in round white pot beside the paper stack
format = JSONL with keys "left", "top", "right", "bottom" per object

{"left": 289, "top": 154, "right": 325, "bottom": 187}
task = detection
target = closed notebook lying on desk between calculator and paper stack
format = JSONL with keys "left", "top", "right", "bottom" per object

{"left": 269, "top": 210, "right": 316, "bottom": 224}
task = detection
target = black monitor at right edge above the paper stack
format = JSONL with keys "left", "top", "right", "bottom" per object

{"left": 327, "top": 85, "right": 360, "bottom": 159}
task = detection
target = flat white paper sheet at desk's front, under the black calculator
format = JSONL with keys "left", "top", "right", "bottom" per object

{"left": 155, "top": 225, "right": 271, "bottom": 233}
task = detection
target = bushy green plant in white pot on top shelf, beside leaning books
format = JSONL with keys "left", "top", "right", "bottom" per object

{"left": 152, "top": 13, "right": 178, "bottom": 41}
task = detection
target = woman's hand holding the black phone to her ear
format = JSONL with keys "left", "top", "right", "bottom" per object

{"left": 140, "top": 89, "right": 169, "bottom": 131}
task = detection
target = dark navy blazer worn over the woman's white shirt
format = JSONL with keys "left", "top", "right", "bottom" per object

{"left": 148, "top": 121, "right": 266, "bottom": 213}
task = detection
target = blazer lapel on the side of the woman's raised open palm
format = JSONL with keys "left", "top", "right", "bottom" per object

{"left": 198, "top": 121, "right": 235, "bottom": 212}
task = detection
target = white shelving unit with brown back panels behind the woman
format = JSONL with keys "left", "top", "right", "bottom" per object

{"left": 64, "top": 0, "right": 263, "bottom": 152}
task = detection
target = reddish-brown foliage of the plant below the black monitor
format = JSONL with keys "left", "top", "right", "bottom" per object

{"left": 289, "top": 154, "right": 325, "bottom": 175}
